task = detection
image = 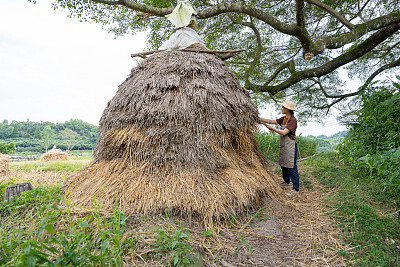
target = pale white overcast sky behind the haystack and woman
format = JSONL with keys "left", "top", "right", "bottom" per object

{"left": 0, "top": 0, "right": 346, "bottom": 136}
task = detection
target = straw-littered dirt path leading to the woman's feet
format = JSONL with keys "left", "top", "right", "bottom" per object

{"left": 208, "top": 167, "right": 346, "bottom": 266}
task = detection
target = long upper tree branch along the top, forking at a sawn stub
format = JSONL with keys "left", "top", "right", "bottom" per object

{"left": 90, "top": 0, "right": 400, "bottom": 63}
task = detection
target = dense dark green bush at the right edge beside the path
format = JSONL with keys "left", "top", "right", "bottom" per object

{"left": 339, "top": 77, "right": 400, "bottom": 204}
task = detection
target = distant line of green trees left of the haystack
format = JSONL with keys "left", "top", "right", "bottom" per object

{"left": 0, "top": 119, "right": 97, "bottom": 153}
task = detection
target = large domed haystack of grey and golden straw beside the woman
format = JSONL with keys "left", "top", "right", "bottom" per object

{"left": 63, "top": 51, "right": 280, "bottom": 225}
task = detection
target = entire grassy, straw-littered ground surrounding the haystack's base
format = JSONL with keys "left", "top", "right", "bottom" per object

{"left": 0, "top": 153, "right": 400, "bottom": 266}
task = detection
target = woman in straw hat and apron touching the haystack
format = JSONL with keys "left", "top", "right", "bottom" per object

{"left": 260, "top": 100, "right": 299, "bottom": 196}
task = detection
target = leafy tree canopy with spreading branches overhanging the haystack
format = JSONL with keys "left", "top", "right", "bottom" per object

{"left": 29, "top": 0, "right": 400, "bottom": 116}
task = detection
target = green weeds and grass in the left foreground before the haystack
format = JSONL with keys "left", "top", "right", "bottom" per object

{"left": 0, "top": 181, "right": 192, "bottom": 266}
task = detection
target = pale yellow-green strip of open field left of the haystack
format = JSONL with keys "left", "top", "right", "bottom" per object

{"left": 10, "top": 159, "right": 90, "bottom": 172}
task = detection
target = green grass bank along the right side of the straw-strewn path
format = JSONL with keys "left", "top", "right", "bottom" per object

{"left": 304, "top": 152, "right": 400, "bottom": 266}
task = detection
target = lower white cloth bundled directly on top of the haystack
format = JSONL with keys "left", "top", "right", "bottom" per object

{"left": 159, "top": 27, "right": 204, "bottom": 50}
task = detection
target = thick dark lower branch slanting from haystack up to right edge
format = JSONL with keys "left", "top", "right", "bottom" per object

{"left": 249, "top": 23, "right": 400, "bottom": 94}
